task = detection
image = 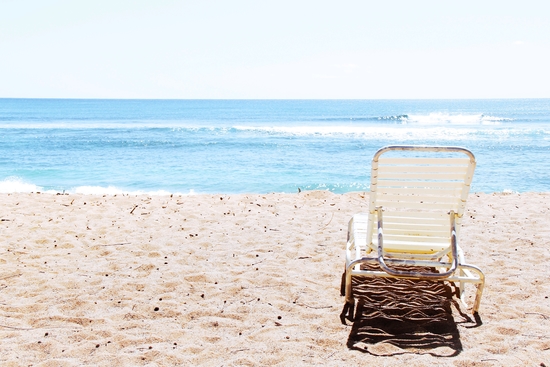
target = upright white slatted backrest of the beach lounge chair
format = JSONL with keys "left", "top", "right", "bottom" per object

{"left": 367, "top": 146, "right": 476, "bottom": 254}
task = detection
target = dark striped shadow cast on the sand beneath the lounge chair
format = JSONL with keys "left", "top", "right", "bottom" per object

{"left": 340, "top": 266, "right": 481, "bottom": 357}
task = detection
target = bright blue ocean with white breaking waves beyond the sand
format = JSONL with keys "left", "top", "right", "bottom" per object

{"left": 0, "top": 99, "right": 550, "bottom": 194}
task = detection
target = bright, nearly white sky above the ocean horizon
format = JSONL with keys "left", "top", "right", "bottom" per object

{"left": 0, "top": 0, "right": 550, "bottom": 99}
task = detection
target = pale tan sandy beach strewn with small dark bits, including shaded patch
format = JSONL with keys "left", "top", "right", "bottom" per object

{"left": 0, "top": 191, "right": 550, "bottom": 367}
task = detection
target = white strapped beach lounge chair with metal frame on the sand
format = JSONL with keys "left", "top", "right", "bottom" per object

{"left": 343, "top": 146, "right": 485, "bottom": 318}
